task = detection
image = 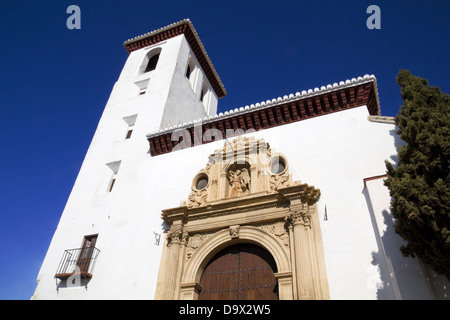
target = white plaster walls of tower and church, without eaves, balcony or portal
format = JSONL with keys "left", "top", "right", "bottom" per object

{"left": 33, "top": 31, "right": 442, "bottom": 299}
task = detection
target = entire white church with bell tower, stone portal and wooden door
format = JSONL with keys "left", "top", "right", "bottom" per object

{"left": 32, "top": 20, "right": 448, "bottom": 300}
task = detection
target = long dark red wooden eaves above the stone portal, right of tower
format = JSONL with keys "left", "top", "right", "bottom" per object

{"left": 148, "top": 81, "right": 379, "bottom": 156}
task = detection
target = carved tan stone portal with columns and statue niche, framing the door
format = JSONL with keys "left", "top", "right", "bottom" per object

{"left": 156, "top": 137, "right": 329, "bottom": 299}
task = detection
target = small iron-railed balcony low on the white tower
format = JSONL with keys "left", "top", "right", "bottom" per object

{"left": 55, "top": 247, "right": 100, "bottom": 280}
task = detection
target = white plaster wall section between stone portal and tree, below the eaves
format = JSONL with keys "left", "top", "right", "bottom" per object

{"left": 246, "top": 107, "right": 396, "bottom": 299}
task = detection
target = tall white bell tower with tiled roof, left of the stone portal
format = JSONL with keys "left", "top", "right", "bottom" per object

{"left": 32, "top": 19, "right": 226, "bottom": 299}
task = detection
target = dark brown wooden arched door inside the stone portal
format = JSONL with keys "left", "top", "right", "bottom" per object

{"left": 199, "top": 243, "right": 278, "bottom": 300}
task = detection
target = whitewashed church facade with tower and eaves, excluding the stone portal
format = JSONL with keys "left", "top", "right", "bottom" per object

{"left": 32, "top": 20, "right": 448, "bottom": 299}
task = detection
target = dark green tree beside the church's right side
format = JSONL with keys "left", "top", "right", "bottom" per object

{"left": 385, "top": 70, "right": 450, "bottom": 280}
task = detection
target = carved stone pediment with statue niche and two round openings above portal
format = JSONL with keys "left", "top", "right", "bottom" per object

{"left": 181, "top": 136, "right": 320, "bottom": 208}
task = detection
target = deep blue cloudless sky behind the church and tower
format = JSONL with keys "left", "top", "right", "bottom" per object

{"left": 0, "top": 0, "right": 450, "bottom": 299}
